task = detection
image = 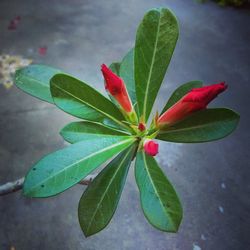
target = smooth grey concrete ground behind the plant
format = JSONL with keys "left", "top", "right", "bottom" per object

{"left": 0, "top": 0, "right": 250, "bottom": 250}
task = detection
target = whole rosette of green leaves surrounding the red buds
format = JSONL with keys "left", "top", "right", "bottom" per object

{"left": 15, "top": 8, "right": 239, "bottom": 236}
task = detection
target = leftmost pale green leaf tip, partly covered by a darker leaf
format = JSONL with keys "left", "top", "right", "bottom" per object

{"left": 15, "top": 64, "right": 61, "bottom": 104}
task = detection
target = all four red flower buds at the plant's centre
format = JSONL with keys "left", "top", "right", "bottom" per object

{"left": 101, "top": 64, "right": 227, "bottom": 156}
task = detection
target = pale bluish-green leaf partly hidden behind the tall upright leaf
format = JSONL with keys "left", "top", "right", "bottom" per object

{"left": 119, "top": 48, "right": 137, "bottom": 105}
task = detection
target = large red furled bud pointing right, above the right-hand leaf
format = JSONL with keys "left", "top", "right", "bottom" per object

{"left": 157, "top": 82, "right": 227, "bottom": 127}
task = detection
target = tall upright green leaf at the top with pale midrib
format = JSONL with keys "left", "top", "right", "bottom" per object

{"left": 134, "top": 8, "right": 179, "bottom": 121}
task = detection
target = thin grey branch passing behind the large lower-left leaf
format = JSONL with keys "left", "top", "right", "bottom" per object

{"left": 0, "top": 174, "right": 96, "bottom": 196}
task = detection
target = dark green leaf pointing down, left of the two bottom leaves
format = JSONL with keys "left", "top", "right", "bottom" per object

{"left": 78, "top": 145, "right": 135, "bottom": 237}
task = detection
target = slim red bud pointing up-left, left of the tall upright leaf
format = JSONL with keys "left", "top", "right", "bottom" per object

{"left": 101, "top": 64, "right": 133, "bottom": 113}
